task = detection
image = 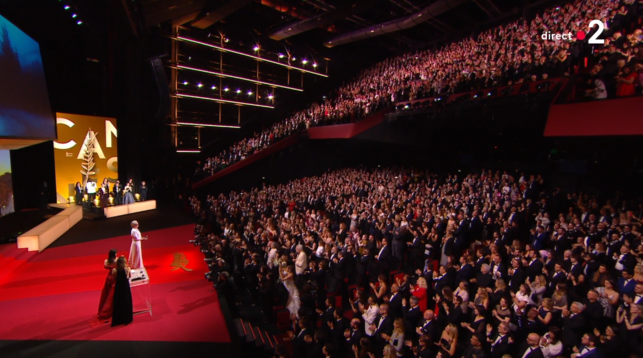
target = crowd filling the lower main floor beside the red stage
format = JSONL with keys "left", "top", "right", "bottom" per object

{"left": 191, "top": 168, "right": 643, "bottom": 358}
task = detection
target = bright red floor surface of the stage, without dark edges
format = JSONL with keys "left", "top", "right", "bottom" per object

{"left": 0, "top": 225, "right": 230, "bottom": 343}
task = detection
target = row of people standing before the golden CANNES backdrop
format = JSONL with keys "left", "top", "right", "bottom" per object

{"left": 75, "top": 178, "right": 147, "bottom": 208}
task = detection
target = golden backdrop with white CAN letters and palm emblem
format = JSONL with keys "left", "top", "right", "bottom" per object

{"left": 54, "top": 113, "right": 118, "bottom": 203}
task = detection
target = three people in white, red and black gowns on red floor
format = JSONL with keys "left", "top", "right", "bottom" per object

{"left": 90, "top": 220, "right": 147, "bottom": 327}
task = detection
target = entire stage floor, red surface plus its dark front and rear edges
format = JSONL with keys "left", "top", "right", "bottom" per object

{"left": 0, "top": 204, "right": 232, "bottom": 357}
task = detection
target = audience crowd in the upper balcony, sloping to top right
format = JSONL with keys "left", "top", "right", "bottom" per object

{"left": 196, "top": 0, "right": 643, "bottom": 178}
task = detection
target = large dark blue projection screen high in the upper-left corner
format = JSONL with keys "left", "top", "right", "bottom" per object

{"left": 0, "top": 15, "right": 56, "bottom": 140}
